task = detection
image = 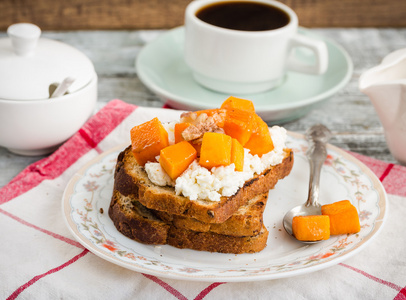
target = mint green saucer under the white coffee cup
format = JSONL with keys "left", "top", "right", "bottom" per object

{"left": 136, "top": 27, "right": 353, "bottom": 123}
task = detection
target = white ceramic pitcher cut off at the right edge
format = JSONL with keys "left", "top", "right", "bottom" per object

{"left": 359, "top": 48, "right": 406, "bottom": 164}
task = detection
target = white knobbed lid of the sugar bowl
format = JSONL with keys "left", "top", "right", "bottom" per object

{"left": 0, "top": 23, "right": 95, "bottom": 100}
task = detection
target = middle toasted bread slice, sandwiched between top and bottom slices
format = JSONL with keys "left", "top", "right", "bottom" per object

{"left": 157, "top": 193, "right": 268, "bottom": 236}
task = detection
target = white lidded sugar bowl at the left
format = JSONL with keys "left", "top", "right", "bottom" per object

{"left": 0, "top": 23, "right": 97, "bottom": 155}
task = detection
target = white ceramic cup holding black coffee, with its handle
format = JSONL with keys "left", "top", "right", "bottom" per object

{"left": 184, "top": 0, "right": 328, "bottom": 95}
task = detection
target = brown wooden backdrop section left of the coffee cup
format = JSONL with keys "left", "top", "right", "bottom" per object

{"left": 0, "top": 0, "right": 189, "bottom": 30}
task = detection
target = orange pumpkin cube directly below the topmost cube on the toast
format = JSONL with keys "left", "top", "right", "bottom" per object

{"left": 223, "top": 109, "right": 255, "bottom": 146}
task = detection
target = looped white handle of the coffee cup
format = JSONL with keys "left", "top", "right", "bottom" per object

{"left": 287, "top": 34, "right": 328, "bottom": 75}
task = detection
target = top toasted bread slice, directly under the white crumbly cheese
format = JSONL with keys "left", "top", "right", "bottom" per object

{"left": 114, "top": 146, "right": 293, "bottom": 223}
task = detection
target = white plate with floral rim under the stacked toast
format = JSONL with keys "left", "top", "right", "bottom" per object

{"left": 63, "top": 133, "right": 387, "bottom": 282}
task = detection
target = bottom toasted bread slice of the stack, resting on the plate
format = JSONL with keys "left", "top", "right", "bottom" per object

{"left": 109, "top": 191, "right": 268, "bottom": 254}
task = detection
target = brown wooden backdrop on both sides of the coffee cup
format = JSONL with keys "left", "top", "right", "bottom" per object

{"left": 0, "top": 0, "right": 406, "bottom": 30}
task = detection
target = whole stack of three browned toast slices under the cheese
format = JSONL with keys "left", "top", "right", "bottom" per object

{"left": 109, "top": 146, "right": 293, "bottom": 254}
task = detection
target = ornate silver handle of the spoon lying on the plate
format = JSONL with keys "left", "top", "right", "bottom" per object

{"left": 306, "top": 124, "right": 332, "bottom": 206}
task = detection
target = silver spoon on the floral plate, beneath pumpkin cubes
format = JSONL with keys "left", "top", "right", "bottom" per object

{"left": 283, "top": 124, "right": 332, "bottom": 244}
